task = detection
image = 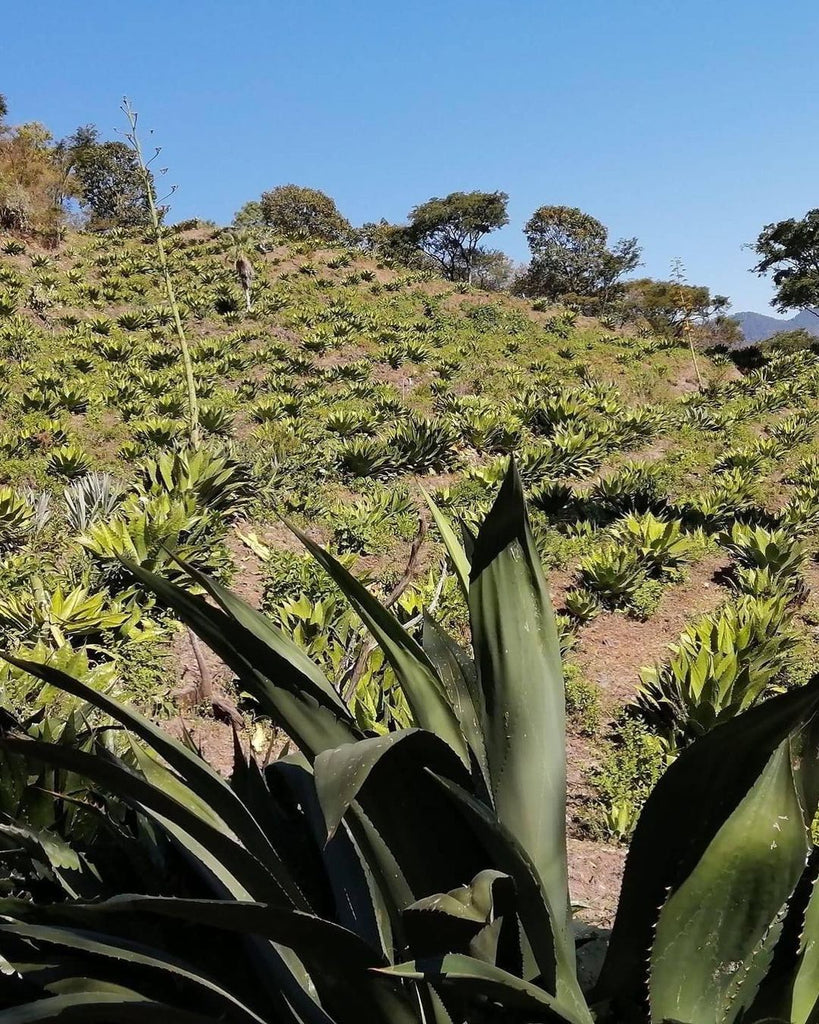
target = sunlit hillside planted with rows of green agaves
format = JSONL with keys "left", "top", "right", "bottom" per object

{"left": 0, "top": 225, "right": 819, "bottom": 920}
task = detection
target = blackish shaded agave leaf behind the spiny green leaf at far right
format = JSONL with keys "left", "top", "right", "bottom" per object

{"left": 596, "top": 677, "right": 819, "bottom": 1013}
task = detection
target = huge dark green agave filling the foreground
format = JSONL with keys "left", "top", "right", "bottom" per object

{"left": 0, "top": 468, "right": 819, "bottom": 1024}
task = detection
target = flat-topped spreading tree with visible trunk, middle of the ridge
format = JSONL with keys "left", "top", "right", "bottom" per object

{"left": 410, "top": 191, "right": 509, "bottom": 283}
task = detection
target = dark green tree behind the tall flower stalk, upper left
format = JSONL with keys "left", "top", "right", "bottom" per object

{"left": 61, "top": 125, "right": 149, "bottom": 227}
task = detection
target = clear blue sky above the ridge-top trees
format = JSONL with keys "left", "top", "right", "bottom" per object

{"left": 0, "top": 0, "right": 819, "bottom": 311}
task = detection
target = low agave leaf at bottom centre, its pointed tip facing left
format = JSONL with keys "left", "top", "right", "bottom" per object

{"left": 378, "top": 953, "right": 577, "bottom": 1024}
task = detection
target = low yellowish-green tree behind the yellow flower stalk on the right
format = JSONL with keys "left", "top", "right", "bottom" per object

{"left": 622, "top": 278, "right": 731, "bottom": 337}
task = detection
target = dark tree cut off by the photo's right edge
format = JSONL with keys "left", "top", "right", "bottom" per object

{"left": 752, "top": 209, "right": 819, "bottom": 316}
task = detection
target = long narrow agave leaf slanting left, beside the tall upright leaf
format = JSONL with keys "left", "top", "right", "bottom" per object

{"left": 290, "top": 525, "right": 469, "bottom": 764}
